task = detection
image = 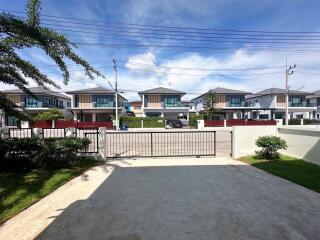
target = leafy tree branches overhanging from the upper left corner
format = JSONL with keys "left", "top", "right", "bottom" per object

{"left": 0, "top": 0, "right": 102, "bottom": 118}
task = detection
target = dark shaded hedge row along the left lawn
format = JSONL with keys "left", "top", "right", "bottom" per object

{"left": 0, "top": 138, "right": 90, "bottom": 170}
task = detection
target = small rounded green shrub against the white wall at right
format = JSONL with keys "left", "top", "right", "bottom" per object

{"left": 256, "top": 136, "right": 288, "bottom": 159}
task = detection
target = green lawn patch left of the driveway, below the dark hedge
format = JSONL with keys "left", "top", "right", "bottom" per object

{"left": 0, "top": 158, "right": 98, "bottom": 224}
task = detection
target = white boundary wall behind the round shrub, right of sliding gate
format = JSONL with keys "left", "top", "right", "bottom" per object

{"left": 232, "top": 126, "right": 320, "bottom": 165}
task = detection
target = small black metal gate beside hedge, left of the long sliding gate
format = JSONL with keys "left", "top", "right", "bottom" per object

{"left": 76, "top": 128, "right": 99, "bottom": 153}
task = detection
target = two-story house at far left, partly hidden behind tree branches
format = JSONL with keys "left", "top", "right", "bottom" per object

{"left": 1, "top": 87, "right": 71, "bottom": 126}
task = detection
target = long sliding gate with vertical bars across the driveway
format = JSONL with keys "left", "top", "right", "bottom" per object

{"left": 106, "top": 131, "right": 216, "bottom": 158}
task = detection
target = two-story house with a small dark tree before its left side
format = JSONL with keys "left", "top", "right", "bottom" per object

{"left": 191, "top": 87, "right": 253, "bottom": 119}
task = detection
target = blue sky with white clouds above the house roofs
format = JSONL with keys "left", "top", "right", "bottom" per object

{"left": 0, "top": 0, "right": 320, "bottom": 100}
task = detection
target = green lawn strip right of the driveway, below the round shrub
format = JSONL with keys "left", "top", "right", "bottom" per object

{"left": 239, "top": 155, "right": 320, "bottom": 193}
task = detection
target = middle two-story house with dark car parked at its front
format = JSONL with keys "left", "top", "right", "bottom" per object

{"left": 138, "top": 87, "right": 189, "bottom": 120}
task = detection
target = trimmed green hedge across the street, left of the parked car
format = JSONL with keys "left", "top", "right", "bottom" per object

{"left": 119, "top": 116, "right": 165, "bottom": 128}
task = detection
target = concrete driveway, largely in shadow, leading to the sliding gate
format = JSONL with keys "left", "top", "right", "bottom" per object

{"left": 0, "top": 158, "right": 320, "bottom": 240}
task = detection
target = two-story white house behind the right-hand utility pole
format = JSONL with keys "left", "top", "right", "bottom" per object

{"left": 246, "top": 88, "right": 317, "bottom": 119}
